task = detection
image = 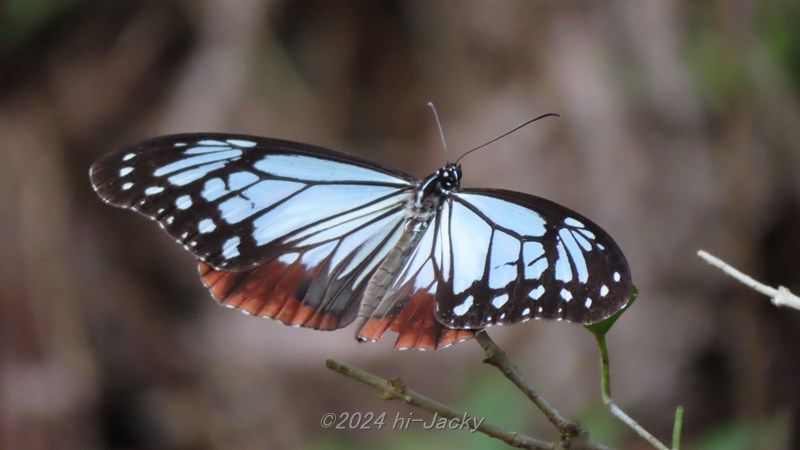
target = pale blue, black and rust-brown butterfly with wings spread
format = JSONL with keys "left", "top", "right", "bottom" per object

{"left": 90, "top": 133, "right": 631, "bottom": 349}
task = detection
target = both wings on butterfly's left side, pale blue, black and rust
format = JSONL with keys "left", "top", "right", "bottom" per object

{"left": 90, "top": 133, "right": 414, "bottom": 329}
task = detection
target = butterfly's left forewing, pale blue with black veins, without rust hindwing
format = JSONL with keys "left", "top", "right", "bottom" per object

{"left": 90, "top": 133, "right": 414, "bottom": 271}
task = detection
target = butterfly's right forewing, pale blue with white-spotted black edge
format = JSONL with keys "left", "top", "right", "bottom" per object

{"left": 433, "top": 189, "right": 631, "bottom": 329}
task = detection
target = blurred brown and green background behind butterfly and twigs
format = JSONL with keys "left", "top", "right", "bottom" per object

{"left": 0, "top": 0, "right": 800, "bottom": 449}
